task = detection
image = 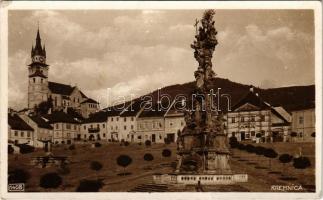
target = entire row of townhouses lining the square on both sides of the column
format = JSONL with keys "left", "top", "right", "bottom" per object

{"left": 8, "top": 88, "right": 315, "bottom": 147}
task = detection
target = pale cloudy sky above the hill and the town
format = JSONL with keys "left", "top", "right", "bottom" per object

{"left": 8, "top": 10, "right": 314, "bottom": 109}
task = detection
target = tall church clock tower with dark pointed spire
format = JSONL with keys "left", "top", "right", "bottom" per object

{"left": 28, "top": 28, "right": 49, "bottom": 109}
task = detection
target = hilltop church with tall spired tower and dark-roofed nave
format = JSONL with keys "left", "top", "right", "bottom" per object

{"left": 28, "top": 29, "right": 99, "bottom": 117}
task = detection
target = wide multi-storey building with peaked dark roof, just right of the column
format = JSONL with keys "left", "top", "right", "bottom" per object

{"left": 225, "top": 88, "right": 291, "bottom": 142}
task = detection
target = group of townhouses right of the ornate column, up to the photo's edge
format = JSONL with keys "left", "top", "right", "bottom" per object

{"left": 224, "top": 88, "right": 315, "bottom": 142}
